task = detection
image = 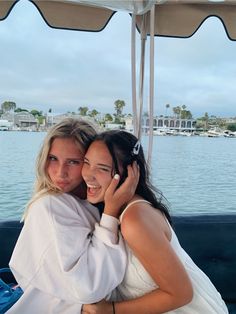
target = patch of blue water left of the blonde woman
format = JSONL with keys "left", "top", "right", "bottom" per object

{"left": 0, "top": 132, "right": 45, "bottom": 218}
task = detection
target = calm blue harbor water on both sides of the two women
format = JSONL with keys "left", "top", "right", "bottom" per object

{"left": 0, "top": 132, "right": 236, "bottom": 219}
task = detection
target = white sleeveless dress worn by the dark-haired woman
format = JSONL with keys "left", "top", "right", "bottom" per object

{"left": 115, "top": 200, "right": 228, "bottom": 314}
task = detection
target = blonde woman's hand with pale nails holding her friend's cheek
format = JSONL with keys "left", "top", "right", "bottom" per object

{"left": 104, "top": 161, "right": 139, "bottom": 218}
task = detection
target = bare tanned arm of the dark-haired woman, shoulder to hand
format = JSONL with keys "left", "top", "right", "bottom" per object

{"left": 83, "top": 204, "right": 193, "bottom": 314}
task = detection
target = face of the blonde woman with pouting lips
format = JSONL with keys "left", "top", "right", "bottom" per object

{"left": 47, "top": 137, "right": 84, "bottom": 192}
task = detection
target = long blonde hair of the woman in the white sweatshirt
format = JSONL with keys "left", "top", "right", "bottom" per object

{"left": 22, "top": 118, "right": 97, "bottom": 221}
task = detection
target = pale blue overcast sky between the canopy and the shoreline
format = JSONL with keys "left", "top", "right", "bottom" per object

{"left": 0, "top": 0, "right": 236, "bottom": 117}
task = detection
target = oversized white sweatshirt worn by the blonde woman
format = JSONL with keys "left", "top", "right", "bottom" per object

{"left": 10, "top": 194, "right": 126, "bottom": 304}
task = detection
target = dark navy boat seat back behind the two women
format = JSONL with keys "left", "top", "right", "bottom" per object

{"left": 0, "top": 214, "right": 236, "bottom": 314}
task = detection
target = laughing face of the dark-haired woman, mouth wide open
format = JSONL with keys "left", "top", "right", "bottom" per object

{"left": 82, "top": 141, "right": 113, "bottom": 204}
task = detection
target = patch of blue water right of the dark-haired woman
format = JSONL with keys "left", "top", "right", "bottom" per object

{"left": 146, "top": 136, "right": 236, "bottom": 213}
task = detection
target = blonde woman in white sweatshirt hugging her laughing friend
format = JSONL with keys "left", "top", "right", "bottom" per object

{"left": 8, "top": 119, "right": 138, "bottom": 314}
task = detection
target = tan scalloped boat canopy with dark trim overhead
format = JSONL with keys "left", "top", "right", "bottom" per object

{"left": 0, "top": 0, "right": 236, "bottom": 40}
